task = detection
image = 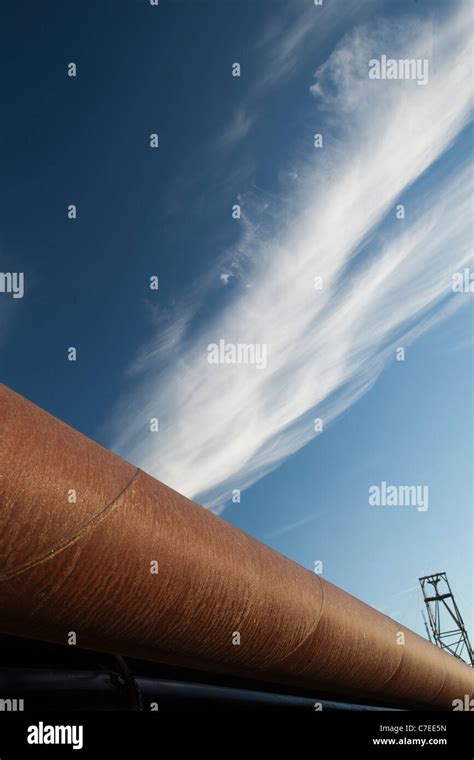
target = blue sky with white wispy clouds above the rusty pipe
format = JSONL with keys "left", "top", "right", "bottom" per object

{"left": 0, "top": 0, "right": 474, "bottom": 634}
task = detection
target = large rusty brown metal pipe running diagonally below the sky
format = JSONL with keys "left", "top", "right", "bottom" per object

{"left": 0, "top": 385, "right": 473, "bottom": 709}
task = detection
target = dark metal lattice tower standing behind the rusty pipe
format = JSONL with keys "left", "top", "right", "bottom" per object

{"left": 418, "top": 573, "right": 474, "bottom": 666}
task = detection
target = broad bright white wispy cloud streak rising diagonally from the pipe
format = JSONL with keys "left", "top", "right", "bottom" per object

{"left": 107, "top": 4, "right": 472, "bottom": 508}
